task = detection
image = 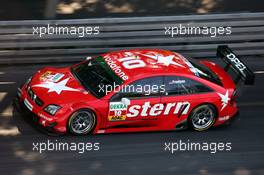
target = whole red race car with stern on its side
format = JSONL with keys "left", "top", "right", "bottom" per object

{"left": 14, "top": 46, "right": 254, "bottom": 135}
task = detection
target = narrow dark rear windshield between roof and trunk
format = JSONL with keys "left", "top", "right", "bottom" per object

{"left": 189, "top": 59, "right": 223, "bottom": 86}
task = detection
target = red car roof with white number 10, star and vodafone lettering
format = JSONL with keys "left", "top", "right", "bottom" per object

{"left": 102, "top": 49, "right": 195, "bottom": 79}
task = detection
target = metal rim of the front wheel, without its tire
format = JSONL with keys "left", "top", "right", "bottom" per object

{"left": 71, "top": 111, "right": 94, "bottom": 134}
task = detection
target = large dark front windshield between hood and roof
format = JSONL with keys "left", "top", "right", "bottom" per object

{"left": 71, "top": 56, "right": 123, "bottom": 98}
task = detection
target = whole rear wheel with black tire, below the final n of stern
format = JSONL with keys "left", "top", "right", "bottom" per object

{"left": 189, "top": 104, "right": 217, "bottom": 131}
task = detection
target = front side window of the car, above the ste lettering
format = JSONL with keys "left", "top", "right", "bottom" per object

{"left": 111, "top": 76, "right": 165, "bottom": 101}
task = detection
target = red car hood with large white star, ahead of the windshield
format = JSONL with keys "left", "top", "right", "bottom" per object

{"left": 29, "top": 67, "right": 96, "bottom": 105}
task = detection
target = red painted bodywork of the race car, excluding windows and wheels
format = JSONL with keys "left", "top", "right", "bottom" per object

{"left": 17, "top": 49, "right": 238, "bottom": 133}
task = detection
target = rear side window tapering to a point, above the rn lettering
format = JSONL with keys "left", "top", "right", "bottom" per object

{"left": 164, "top": 76, "right": 213, "bottom": 95}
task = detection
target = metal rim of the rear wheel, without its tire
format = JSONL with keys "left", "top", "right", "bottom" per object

{"left": 192, "top": 106, "right": 214, "bottom": 129}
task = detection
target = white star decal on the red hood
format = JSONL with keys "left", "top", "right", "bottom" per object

{"left": 32, "top": 78, "right": 79, "bottom": 94}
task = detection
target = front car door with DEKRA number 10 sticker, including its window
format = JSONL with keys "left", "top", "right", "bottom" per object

{"left": 107, "top": 76, "right": 163, "bottom": 128}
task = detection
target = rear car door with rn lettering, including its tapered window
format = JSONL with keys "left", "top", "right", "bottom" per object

{"left": 161, "top": 76, "right": 213, "bottom": 128}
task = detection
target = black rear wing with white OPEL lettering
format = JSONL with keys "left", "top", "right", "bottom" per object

{"left": 216, "top": 45, "right": 255, "bottom": 85}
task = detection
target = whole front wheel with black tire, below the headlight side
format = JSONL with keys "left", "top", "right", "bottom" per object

{"left": 68, "top": 109, "right": 96, "bottom": 135}
